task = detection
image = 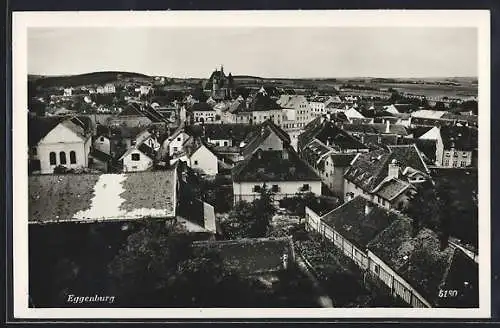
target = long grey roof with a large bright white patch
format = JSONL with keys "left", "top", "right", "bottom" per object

{"left": 28, "top": 170, "right": 176, "bottom": 222}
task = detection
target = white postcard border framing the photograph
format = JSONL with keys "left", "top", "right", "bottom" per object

{"left": 12, "top": 10, "right": 491, "bottom": 319}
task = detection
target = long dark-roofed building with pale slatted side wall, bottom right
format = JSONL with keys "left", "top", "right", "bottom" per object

{"left": 305, "top": 196, "right": 479, "bottom": 308}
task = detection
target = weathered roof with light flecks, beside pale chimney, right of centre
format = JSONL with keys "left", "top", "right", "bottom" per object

{"left": 344, "top": 144, "right": 428, "bottom": 192}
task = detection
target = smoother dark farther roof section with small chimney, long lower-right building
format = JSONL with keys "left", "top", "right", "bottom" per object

{"left": 321, "top": 196, "right": 396, "bottom": 251}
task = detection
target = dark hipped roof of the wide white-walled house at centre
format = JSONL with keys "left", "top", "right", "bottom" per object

{"left": 232, "top": 149, "right": 321, "bottom": 182}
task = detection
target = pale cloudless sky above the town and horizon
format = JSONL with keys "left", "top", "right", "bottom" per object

{"left": 28, "top": 27, "right": 478, "bottom": 78}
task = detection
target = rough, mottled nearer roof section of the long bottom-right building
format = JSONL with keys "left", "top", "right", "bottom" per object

{"left": 368, "top": 223, "right": 455, "bottom": 305}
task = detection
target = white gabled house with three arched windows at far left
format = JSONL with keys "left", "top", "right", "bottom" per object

{"left": 28, "top": 117, "right": 92, "bottom": 174}
